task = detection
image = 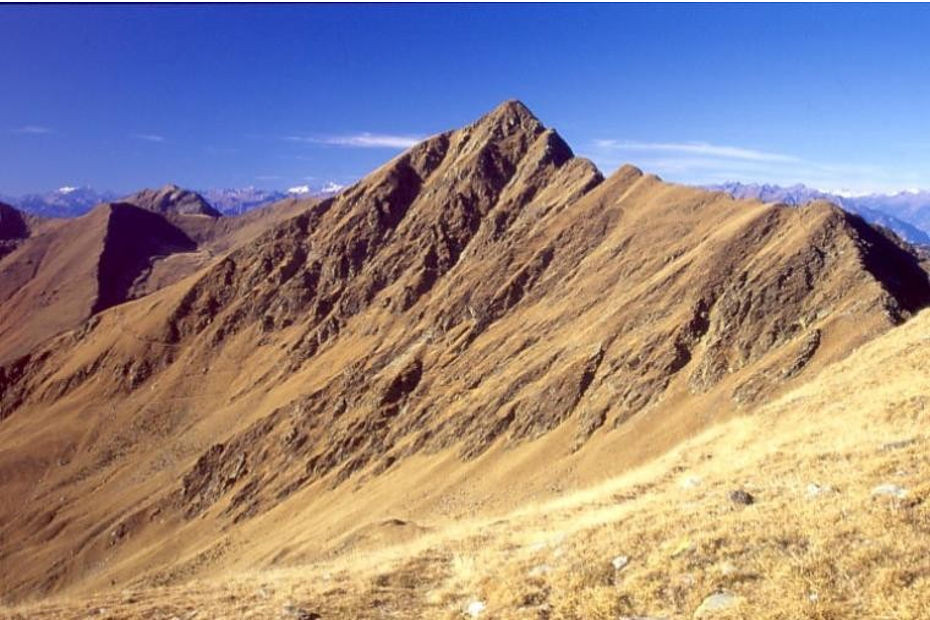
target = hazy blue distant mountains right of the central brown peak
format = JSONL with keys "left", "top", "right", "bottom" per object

{"left": 707, "top": 182, "right": 930, "bottom": 244}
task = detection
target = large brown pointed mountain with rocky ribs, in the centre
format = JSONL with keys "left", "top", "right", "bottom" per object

{"left": 0, "top": 102, "right": 930, "bottom": 596}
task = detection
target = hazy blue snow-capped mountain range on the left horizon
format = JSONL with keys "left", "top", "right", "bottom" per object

{"left": 0, "top": 183, "right": 343, "bottom": 217}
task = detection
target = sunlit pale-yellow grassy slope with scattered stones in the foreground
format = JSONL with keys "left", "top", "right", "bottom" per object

{"left": 7, "top": 313, "right": 930, "bottom": 619}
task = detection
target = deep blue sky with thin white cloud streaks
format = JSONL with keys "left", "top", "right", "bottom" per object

{"left": 0, "top": 4, "right": 930, "bottom": 194}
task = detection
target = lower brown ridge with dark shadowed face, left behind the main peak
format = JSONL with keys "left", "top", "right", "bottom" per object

{"left": 0, "top": 192, "right": 313, "bottom": 362}
